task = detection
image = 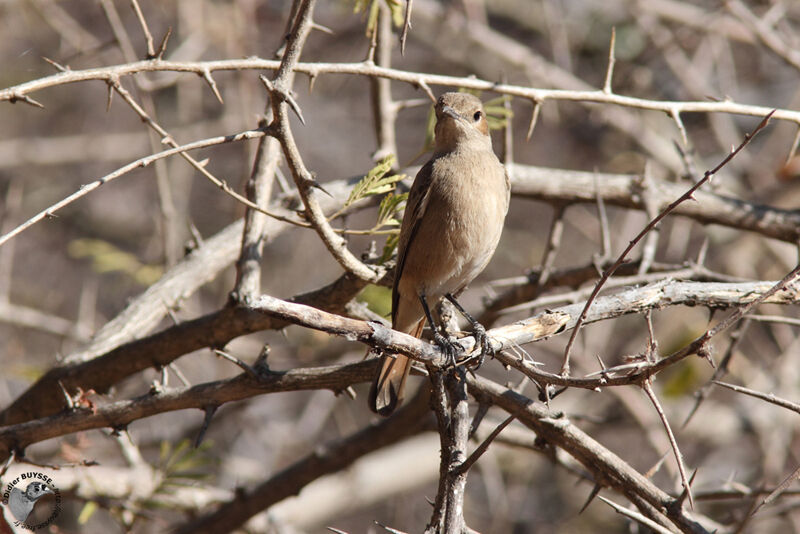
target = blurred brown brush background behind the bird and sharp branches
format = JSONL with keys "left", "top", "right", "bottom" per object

{"left": 0, "top": 0, "right": 800, "bottom": 533}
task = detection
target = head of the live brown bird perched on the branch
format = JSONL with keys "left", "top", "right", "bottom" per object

{"left": 436, "top": 93, "right": 492, "bottom": 151}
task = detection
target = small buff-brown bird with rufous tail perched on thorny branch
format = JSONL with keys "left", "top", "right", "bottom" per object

{"left": 369, "top": 93, "right": 510, "bottom": 416}
